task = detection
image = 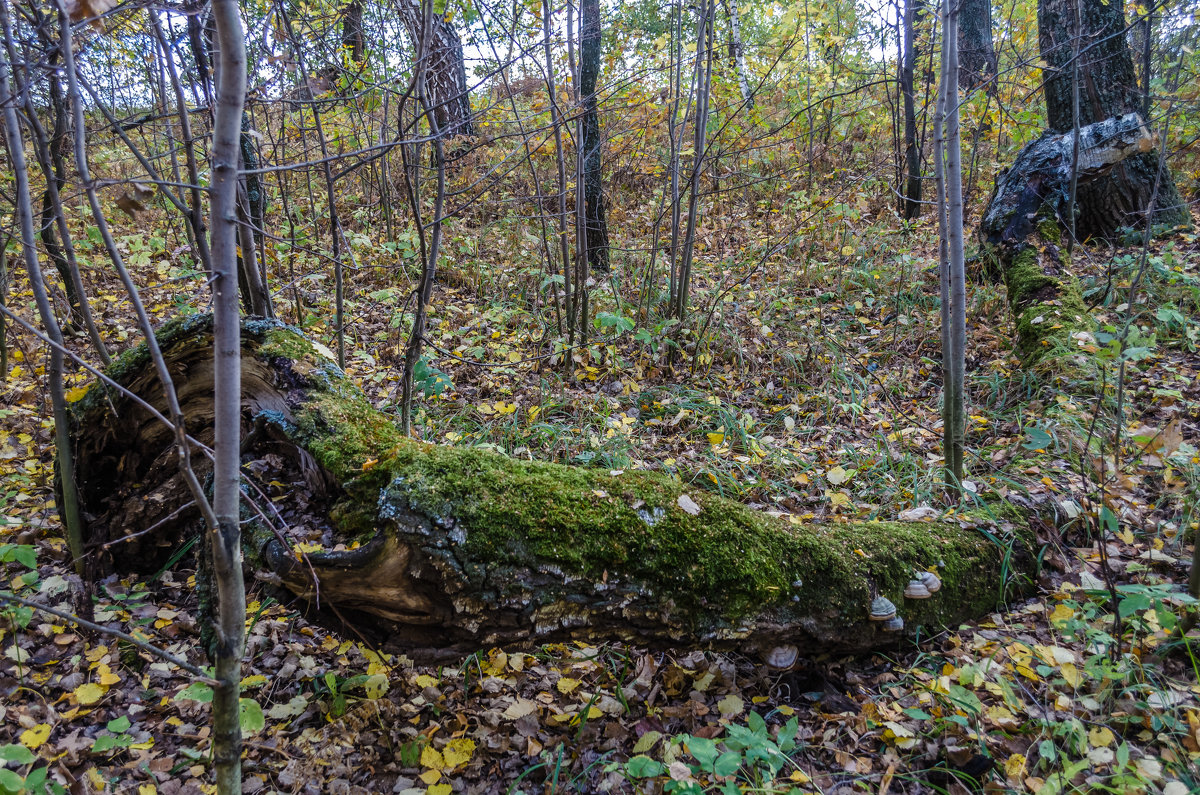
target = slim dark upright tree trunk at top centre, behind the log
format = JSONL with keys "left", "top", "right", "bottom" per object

{"left": 580, "top": 0, "right": 608, "bottom": 273}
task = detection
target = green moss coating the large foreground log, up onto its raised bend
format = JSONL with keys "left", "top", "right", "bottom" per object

{"left": 246, "top": 321, "right": 1024, "bottom": 628}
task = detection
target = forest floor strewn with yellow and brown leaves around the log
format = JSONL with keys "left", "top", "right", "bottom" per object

{"left": 0, "top": 206, "right": 1200, "bottom": 795}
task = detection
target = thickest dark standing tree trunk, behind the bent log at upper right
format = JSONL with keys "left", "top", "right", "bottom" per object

{"left": 1038, "top": 0, "right": 1190, "bottom": 239}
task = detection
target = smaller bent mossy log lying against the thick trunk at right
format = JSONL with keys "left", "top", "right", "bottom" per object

{"left": 979, "top": 113, "right": 1153, "bottom": 359}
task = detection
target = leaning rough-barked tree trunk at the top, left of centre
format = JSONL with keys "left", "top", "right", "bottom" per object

{"left": 400, "top": 0, "right": 475, "bottom": 138}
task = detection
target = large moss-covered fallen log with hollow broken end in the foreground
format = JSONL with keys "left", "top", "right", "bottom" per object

{"left": 73, "top": 317, "right": 1032, "bottom": 656}
